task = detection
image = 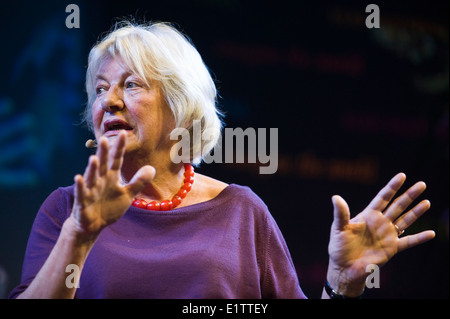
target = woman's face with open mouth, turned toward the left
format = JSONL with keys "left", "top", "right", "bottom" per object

{"left": 92, "top": 57, "right": 175, "bottom": 160}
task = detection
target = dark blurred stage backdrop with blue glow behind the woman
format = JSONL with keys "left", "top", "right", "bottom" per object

{"left": 0, "top": 0, "right": 449, "bottom": 298}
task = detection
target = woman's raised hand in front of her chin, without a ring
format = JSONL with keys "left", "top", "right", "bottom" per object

{"left": 70, "top": 132, "right": 155, "bottom": 237}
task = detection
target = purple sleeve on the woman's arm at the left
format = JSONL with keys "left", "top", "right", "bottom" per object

{"left": 8, "top": 188, "right": 73, "bottom": 299}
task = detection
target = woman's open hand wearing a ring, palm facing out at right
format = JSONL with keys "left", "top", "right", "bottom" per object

{"left": 327, "top": 173, "right": 435, "bottom": 297}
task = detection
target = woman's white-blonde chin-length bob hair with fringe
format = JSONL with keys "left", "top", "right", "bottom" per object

{"left": 84, "top": 21, "right": 223, "bottom": 164}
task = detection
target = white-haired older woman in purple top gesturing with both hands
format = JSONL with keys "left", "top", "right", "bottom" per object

{"left": 10, "top": 23, "right": 434, "bottom": 298}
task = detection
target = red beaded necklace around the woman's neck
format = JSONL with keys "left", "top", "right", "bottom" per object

{"left": 132, "top": 164, "right": 194, "bottom": 210}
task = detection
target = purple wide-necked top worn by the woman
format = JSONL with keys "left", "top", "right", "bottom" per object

{"left": 9, "top": 184, "right": 306, "bottom": 299}
